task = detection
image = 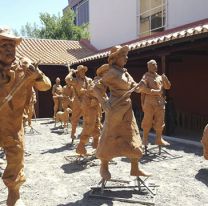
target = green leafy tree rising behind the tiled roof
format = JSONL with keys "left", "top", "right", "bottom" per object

{"left": 17, "top": 9, "right": 89, "bottom": 40}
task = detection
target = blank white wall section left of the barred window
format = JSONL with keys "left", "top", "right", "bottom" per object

{"left": 89, "top": 0, "right": 138, "bottom": 49}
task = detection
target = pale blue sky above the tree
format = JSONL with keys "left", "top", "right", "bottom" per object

{"left": 0, "top": 0, "right": 68, "bottom": 31}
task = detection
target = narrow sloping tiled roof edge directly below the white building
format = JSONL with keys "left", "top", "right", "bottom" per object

{"left": 71, "top": 23, "right": 208, "bottom": 65}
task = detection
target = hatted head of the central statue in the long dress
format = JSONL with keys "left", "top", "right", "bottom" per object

{"left": 108, "top": 45, "right": 129, "bottom": 68}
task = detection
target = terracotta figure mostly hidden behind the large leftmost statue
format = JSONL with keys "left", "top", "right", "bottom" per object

{"left": 23, "top": 87, "right": 37, "bottom": 127}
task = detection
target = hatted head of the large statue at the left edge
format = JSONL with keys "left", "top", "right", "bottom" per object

{"left": 0, "top": 28, "right": 22, "bottom": 65}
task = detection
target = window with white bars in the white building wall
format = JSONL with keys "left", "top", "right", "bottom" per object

{"left": 139, "top": 0, "right": 167, "bottom": 37}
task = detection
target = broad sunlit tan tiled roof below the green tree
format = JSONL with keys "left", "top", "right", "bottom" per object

{"left": 17, "top": 38, "right": 94, "bottom": 64}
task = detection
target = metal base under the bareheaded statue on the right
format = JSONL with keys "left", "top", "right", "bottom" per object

{"left": 141, "top": 146, "right": 182, "bottom": 163}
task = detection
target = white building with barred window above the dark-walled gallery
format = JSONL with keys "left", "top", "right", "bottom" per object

{"left": 65, "top": 0, "right": 208, "bottom": 49}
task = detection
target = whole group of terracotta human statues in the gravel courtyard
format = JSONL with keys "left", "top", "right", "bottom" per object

{"left": 0, "top": 29, "right": 208, "bottom": 206}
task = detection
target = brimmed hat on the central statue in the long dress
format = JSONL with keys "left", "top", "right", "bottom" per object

{"left": 108, "top": 45, "right": 129, "bottom": 63}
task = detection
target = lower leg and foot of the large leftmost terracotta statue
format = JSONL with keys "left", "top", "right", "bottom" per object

{"left": 7, "top": 189, "right": 25, "bottom": 206}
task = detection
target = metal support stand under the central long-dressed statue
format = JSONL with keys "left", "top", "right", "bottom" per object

{"left": 89, "top": 177, "right": 158, "bottom": 205}
